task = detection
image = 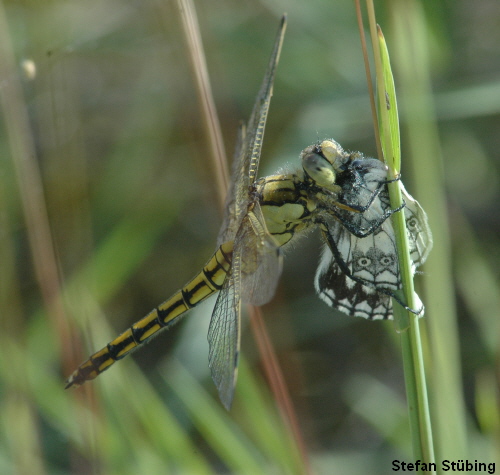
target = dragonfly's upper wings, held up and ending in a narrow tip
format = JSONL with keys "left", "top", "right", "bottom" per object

{"left": 217, "top": 16, "right": 286, "bottom": 245}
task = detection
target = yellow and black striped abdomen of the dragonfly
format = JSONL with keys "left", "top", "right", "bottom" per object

{"left": 66, "top": 242, "right": 233, "bottom": 388}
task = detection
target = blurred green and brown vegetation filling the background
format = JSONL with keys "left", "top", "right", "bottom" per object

{"left": 0, "top": 0, "right": 500, "bottom": 474}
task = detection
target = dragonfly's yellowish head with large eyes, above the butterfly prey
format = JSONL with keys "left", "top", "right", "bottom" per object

{"left": 300, "top": 140, "right": 345, "bottom": 189}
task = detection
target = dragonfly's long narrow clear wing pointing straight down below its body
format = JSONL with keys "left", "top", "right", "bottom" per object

{"left": 208, "top": 260, "right": 241, "bottom": 410}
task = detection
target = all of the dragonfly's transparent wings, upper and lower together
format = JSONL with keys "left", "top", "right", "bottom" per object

{"left": 208, "top": 17, "right": 286, "bottom": 409}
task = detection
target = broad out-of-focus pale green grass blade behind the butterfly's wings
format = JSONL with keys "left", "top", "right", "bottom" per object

{"left": 393, "top": 2, "right": 468, "bottom": 459}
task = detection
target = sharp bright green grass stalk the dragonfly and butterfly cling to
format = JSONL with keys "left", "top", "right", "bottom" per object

{"left": 358, "top": 0, "right": 435, "bottom": 473}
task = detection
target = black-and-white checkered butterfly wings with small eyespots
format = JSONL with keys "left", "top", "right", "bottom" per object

{"left": 315, "top": 187, "right": 432, "bottom": 319}
